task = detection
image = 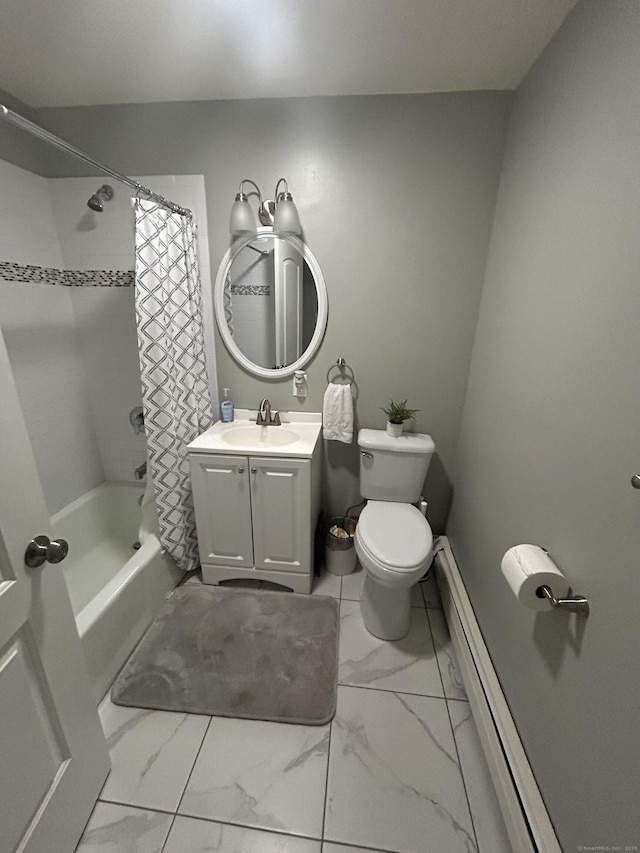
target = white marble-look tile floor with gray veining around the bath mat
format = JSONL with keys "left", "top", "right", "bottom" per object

{"left": 76, "top": 570, "right": 510, "bottom": 853}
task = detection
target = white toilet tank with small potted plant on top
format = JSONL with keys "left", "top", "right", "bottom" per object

{"left": 358, "top": 429, "right": 436, "bottom": 503}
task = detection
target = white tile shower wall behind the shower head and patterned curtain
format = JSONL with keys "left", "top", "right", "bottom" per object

{"left": 49, "top": 175, "right": 217, "bottom": 480}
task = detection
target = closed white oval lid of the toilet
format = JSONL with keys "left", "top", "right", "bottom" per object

{"left": 357, "top": 501, "right": 433, "bottom": 571}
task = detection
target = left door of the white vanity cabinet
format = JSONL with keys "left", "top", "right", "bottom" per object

{"left": 189, "top": 453, "right": 253, "bottom": 568}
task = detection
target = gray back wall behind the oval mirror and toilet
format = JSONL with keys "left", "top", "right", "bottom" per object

{"left": 40, "top": 92, "right": 511, "bottom": 529}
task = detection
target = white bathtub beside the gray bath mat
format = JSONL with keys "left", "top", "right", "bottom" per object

{"left": 51, "top": 482, "right": 182, "bottom": 702}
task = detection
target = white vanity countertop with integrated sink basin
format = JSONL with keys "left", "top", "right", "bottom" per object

{"left": 187, "top": 409, "right": 322, "bottom": 459}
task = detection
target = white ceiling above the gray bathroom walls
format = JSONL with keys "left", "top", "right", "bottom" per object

{"left": 0, "top": 0, "right": 576, "bottom": 107}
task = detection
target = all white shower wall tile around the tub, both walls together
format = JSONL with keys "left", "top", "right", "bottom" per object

{"left": 0, "top": 161, "right": 217, "bottom": 513}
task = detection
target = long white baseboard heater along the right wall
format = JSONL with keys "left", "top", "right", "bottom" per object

{"left": 435, "top": 536, "right": 562, "bottom": 853}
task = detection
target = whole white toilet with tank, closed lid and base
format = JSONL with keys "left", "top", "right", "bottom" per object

{"left": 355, "top": 429, "right": 435, "bottom": 640}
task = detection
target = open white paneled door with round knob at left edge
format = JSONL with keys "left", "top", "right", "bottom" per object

{"left": 0, "top": 334, "right": 109, "bottom": 853}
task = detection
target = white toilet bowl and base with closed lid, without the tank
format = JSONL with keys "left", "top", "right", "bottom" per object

{"left": 355, "top": 500, "right": 433, "bottom": 640}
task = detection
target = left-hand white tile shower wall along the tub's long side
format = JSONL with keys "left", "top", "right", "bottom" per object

{"left": 0, "top": 161, "right": 104, "bottom": 513}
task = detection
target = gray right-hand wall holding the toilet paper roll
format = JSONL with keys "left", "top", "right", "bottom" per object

{"left": 448, "top": 0, "right": 640, "bottom": 851}
